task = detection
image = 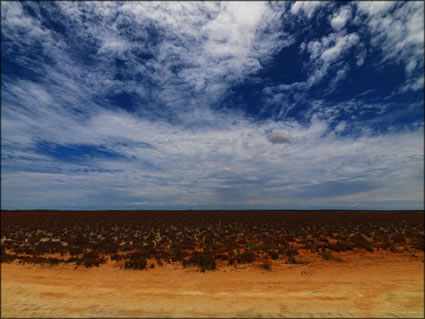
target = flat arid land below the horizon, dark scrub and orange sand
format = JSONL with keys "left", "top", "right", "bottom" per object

{"left": 1, "top": 211, "right": 424, "bottom": 318}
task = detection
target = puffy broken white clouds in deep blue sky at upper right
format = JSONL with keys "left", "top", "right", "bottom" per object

{"left": 263, "top": 2, "right": 424, "bottom": 119}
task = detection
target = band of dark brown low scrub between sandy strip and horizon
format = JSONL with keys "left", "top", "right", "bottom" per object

{"left": 1, "top": 211, "right": 425, "bottom": 271}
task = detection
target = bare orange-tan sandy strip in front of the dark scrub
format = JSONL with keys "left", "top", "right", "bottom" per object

{"left": 1, "top": 253, "right": 424, "bottom": 318}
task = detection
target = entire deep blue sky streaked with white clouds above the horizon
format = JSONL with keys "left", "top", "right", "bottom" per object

{"left": 1, "top": 1, "right": 424, "bottom": 210}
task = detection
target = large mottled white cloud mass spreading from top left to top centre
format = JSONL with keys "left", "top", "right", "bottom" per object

{"left": 2, "top": 2, "right": 294, "bottom": 117}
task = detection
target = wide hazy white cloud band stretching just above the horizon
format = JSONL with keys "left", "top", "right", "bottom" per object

{"left": 2, "top": 99, "right": 423, "bottom": 207}
